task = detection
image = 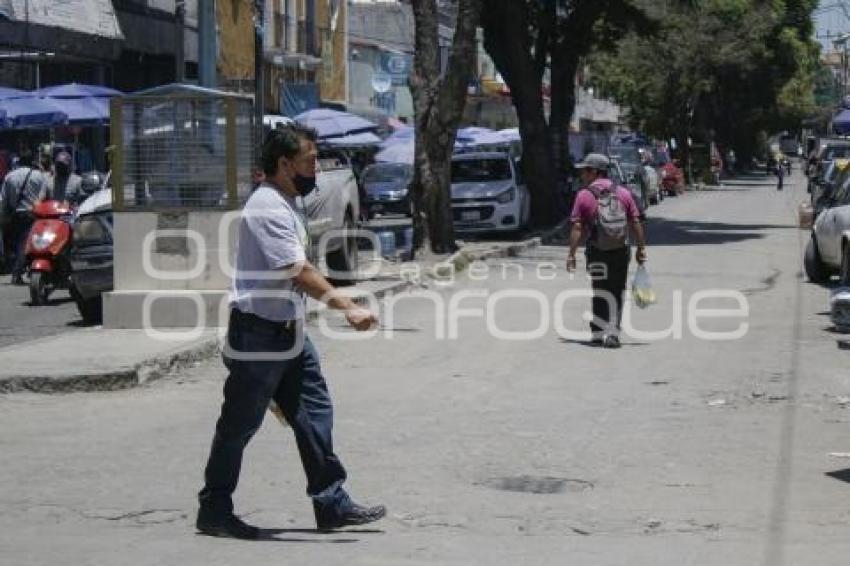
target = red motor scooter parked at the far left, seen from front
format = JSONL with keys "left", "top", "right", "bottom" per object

{"left": 26, "top": 200, "right": 73, "bottom": 305}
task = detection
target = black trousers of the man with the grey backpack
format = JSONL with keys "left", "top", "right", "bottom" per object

{"left": 586, "top": 247, "right": 631, "bottom": 337}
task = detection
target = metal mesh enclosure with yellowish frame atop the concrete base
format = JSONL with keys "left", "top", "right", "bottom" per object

{"left": 112, "top": 91, "right": 254, "bottom": 210}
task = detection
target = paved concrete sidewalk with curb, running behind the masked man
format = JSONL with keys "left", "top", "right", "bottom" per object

{"left": 0, "top": 239, "right": 540, "bottom": 393}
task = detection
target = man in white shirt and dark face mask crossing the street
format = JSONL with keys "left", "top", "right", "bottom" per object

{"left": 196, "top": 126, "right": 386, "bottom": 539}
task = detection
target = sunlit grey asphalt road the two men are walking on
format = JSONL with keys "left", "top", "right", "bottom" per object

{"left": 0, "top": 166, "right": 850, "bottom": 566}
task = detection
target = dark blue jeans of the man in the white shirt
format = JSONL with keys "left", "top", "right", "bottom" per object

{"left": 198, "top": 314, "right": 350, "bottom": 517}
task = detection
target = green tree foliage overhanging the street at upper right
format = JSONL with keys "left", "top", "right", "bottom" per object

{"left": 591, "top": 0, "right": 819, "bottom": 164}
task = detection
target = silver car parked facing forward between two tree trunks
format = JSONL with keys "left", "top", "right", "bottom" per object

{"left": 451, "top": 152, "right": 531, "bottom": 232}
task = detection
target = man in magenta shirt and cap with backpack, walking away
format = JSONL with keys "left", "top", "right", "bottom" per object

{"left": 567, "top": 153, "right": 646, "bottom": 348}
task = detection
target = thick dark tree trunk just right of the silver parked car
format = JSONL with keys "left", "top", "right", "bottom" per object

{"left": 482, "top": 0, "right": 557, "bottom": 226}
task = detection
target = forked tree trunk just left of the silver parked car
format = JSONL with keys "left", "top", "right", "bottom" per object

{"left": 410, "top": 0, "right": 481, "bottom": 253}
